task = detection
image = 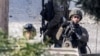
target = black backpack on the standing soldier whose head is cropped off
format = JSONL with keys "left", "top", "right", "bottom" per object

{"left": 40, "top": 0, "right": 55, "bottom": 21}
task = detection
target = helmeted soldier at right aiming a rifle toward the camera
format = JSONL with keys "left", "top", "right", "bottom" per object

{"left": 63, "top": 10, "right": 89, "bottom": 54}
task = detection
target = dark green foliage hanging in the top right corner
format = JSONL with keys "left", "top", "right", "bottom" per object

{"left": 76, "top": 0, "right": 100, "bottom": 21}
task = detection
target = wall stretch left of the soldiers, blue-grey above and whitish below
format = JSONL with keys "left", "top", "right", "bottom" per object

{"left": 9, "top": 0, "right": 42, "bottom": 38}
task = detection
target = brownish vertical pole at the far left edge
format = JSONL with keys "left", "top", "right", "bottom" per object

{"left": 0, "top": 0, "right": 9, "bottom": 33}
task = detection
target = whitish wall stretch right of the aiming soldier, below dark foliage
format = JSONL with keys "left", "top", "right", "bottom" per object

{"left": 80, "top": 15, "right": 100, "bottom": 53}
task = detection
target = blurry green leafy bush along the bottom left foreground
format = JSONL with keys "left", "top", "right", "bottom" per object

{"left": 0, "top": 31, "right": 46, "bottom": 56}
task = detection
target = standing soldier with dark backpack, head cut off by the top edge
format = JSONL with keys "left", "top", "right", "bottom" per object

{"left": 42, "top": 0, "right": 69, "bottom": 47}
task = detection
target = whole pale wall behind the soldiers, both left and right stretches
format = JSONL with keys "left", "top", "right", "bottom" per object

{"left": 9, "top": 0, "right": 100, "bottom": 53}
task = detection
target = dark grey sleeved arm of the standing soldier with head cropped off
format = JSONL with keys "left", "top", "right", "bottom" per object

{"left": 48, "top": 0, "right": 67, "bottom": 29}
